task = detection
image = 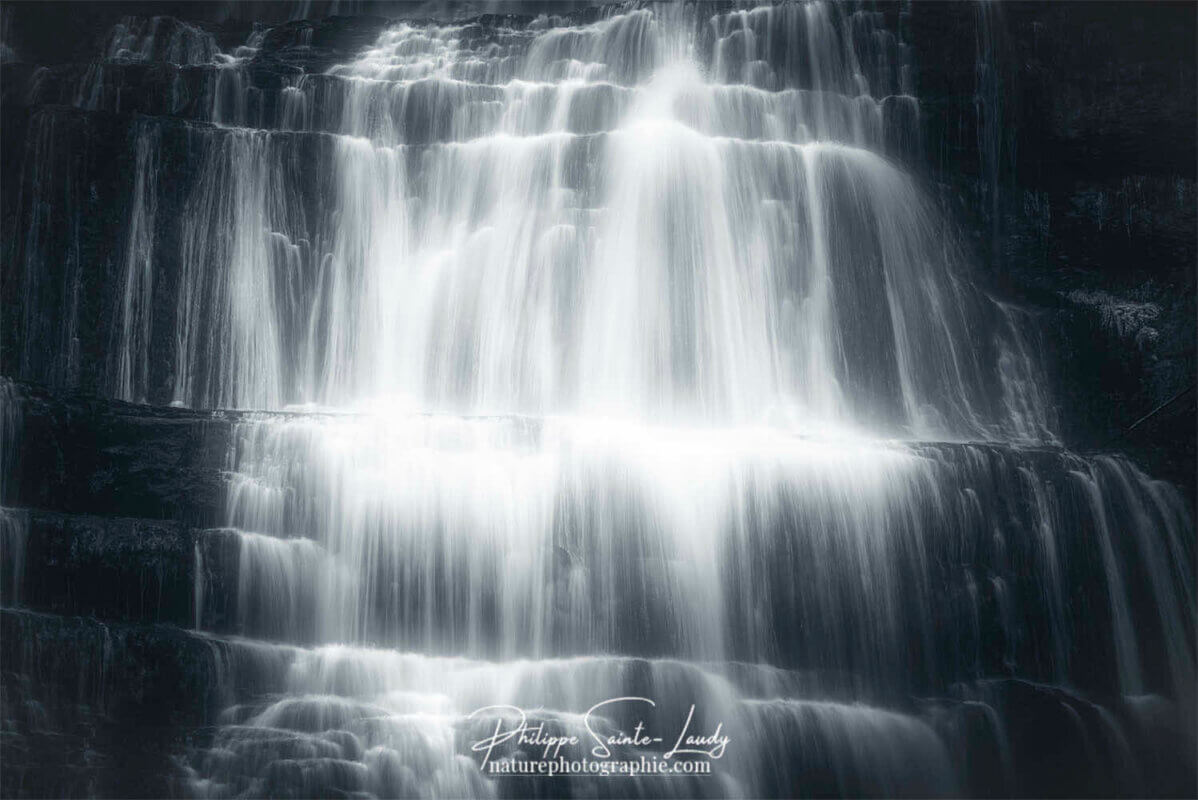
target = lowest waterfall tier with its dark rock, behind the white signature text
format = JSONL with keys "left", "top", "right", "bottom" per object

{"left": 0, "top": 610, "right": 1193, "bottom": 798}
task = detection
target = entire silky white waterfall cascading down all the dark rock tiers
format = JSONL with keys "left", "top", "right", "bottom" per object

{"left": 5, "top": 2, "right": 1194, "bottom": 796}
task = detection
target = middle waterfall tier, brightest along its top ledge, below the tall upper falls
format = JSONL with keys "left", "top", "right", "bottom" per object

{"left": 198, "top": 414, "right": 1193, "bottom": 693}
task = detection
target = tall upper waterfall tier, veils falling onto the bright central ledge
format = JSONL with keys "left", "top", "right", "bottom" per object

{"left": 4, "top": 2, "right": 1053, "bottom": 441}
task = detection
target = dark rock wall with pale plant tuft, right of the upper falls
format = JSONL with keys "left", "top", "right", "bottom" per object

{"left": 909, "top": 2, "right": 1198, "bottom": 497}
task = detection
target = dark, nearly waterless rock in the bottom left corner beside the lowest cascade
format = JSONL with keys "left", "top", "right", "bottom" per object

{"left": 0, "top": 610, "right": 220, "bottom": 798}
